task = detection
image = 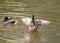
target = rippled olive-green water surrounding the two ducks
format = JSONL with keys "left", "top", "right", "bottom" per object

{"left": 0, "top": 0, "right": 60, "bottom": 43}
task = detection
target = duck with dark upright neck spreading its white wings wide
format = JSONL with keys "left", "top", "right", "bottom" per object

{"left": 21, "top": 15, "right": 50, "bottom": 32}
